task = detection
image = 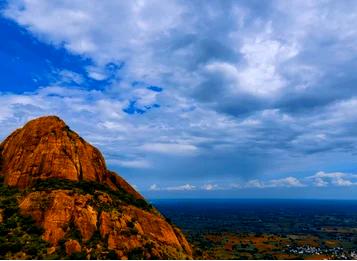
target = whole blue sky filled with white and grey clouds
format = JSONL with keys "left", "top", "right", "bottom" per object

{"left": 0, "top": 0, "right": 357, "bottom": 199}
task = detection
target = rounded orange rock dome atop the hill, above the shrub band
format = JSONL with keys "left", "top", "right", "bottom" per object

{"left": 0, "top": 116, "right": 142, "bottom": 198}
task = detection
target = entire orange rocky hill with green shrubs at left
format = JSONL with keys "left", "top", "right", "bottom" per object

{"left": 0, "top": 116, "right": 192, "bottom": 259}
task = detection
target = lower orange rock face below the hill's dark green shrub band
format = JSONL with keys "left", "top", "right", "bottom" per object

{"left": 19, "top": 190, "right": 192, "bottom": 259}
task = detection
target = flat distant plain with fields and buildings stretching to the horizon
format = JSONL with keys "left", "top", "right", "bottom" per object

{"left": 152, "top": 199, "right": 357, "bottom": 259}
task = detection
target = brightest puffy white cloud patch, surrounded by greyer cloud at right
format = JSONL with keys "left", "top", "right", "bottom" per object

{"left": 205, "top": 32, "right": 298, "bottom": 98}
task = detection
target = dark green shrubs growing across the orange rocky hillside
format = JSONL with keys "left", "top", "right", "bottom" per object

{"left": 0, "top": 177, "right": 153, "bottom": 259}
